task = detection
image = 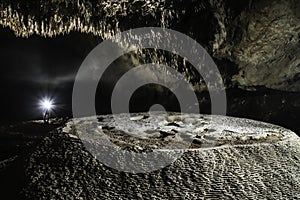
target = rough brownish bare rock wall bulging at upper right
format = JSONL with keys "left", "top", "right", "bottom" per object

{"left": 214, "top": 0, "right": 300, "bottom": 91}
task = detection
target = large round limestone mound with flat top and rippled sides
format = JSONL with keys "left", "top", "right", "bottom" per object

{"left": 23, "top": 112, "right": 300, "bottom": 199}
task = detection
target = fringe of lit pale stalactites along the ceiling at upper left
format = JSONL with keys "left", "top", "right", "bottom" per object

{"left": 0, "top": 0, "right": 176, "bottom": 39}
